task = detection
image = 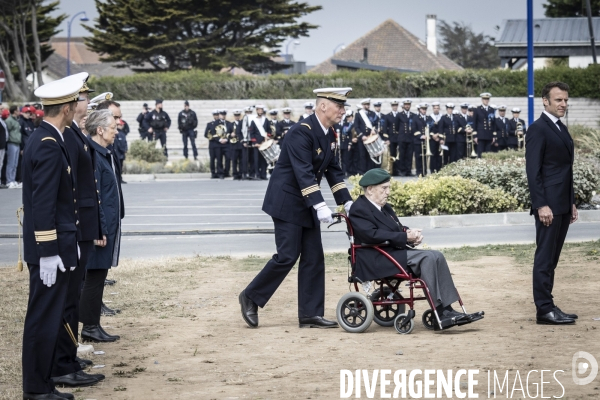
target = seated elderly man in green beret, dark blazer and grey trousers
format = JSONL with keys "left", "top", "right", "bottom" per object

{"left": 350, "top": 168, "right": 481, "bottom": 327}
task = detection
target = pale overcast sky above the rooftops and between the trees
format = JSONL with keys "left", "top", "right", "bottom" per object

{"left": 52, "top": 0, "right": 545, "bottom": 65}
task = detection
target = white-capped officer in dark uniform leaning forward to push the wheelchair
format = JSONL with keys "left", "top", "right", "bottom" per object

{"left": 239, "top": 88, "right": 352, "bottom": 328}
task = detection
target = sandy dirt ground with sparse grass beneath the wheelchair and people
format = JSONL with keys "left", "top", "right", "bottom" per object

{"left": 0, "top": 245, "right": 600, "bottom": 400}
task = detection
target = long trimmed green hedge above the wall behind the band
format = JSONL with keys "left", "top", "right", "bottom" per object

{"left": 90, "top": 66, "right": 600, "bottom": 100}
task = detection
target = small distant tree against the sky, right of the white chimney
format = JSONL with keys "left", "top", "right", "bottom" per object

{"left": 439, "top": 21, "right": 500, "bottom": 68}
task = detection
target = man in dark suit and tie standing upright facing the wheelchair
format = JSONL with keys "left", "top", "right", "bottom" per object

{"left": 525, "top": 82, "right": 578, "bottom": 324}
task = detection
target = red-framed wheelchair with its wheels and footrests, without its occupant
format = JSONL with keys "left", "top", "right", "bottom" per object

{"left": 329, "top": 214, "right": 476, "bottom": 334}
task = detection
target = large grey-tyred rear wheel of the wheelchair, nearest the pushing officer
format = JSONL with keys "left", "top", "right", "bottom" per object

{"left": 336, "top": 292, "right": 374, "bottom": 333}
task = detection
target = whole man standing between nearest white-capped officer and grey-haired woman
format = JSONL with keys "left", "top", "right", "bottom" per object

{"left": 52, "top": 72, "right": 104, "bottom": 387}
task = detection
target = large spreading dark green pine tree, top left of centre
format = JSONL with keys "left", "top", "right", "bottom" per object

{"left": 86, "top": 0, "right": 321, "bottom": 72}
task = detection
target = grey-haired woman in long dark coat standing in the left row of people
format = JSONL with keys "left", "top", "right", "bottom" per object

{"left": 79, "top": 110, "right": 125, "bottom": 342}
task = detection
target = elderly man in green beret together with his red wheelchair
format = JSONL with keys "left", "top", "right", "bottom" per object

{"left": 338, "top": 168, "right": 484, "bottom": 333}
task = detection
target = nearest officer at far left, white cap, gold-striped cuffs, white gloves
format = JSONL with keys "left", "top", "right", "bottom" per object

{"left": 22, "top": 76, "right": 85, "bottom": 400}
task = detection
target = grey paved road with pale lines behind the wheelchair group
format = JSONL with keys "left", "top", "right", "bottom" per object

{"left": 0, "top": 180, "right": 600, "bottom": 265}
